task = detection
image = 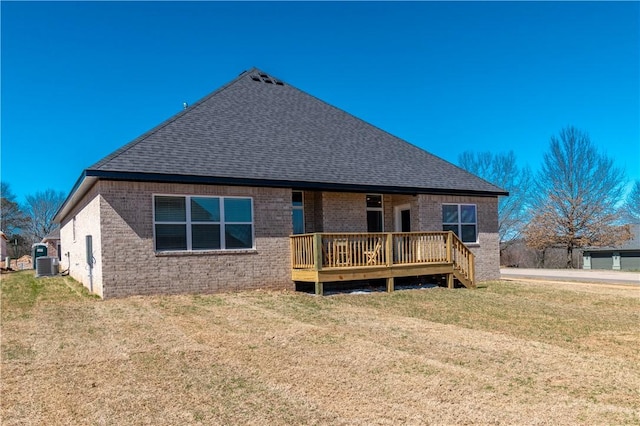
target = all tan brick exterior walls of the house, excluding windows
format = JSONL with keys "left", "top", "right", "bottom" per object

{"left": 60, "top": 181, "right": 500, "bottom": 298}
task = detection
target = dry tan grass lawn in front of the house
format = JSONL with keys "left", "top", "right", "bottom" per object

{"left": 0, "top": 271, "right": 640, "bottom": 426}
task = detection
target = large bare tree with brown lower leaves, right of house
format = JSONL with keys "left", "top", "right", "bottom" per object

{"left": 525, "top": 126, "right": 631, "bottom": 268}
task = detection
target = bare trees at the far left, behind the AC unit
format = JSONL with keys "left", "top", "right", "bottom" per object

{"left": 0, "top": 182, "right": 65, "bottom": 260}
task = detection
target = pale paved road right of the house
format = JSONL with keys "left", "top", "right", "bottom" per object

{"left": 500, "top": 268, "right": 640, "bottom": 285}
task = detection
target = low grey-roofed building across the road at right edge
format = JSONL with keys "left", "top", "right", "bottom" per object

{"left": 582, "top": 223, "right": 640, "bottom": 271}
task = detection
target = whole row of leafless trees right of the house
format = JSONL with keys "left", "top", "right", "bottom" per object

{"left": 458, "top": 126, "right": 640, "bottom": 268}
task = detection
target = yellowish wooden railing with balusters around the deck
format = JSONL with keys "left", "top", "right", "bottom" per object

{"left": 291, "top": 232, "right": 474, "bottom": 288}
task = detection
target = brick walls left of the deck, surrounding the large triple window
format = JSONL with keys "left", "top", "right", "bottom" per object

{"left": 61, "top": 181, "right": 293, "bottom": 298}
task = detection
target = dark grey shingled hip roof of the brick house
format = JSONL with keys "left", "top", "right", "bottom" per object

{"left": 85, "top": 68, "right": 505, "bottom": 195}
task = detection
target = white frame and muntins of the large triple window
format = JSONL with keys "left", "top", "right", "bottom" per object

{"left": 151, "top": 193, "right": 256, "bottom": 253}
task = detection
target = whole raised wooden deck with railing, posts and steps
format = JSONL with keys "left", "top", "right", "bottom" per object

{"left": 291, "top": 232, "right": 475, "bottom": 294}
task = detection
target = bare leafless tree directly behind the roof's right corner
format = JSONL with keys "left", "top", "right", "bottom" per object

{"left": 458, "top": 151, "right": 532, "bottom": 246}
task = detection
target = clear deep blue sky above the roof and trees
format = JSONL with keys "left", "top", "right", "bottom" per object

{"left": 1, "top": 1, "right": 640, "bottom": 205}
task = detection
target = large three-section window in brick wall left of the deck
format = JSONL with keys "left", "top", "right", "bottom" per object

{"left": 153, "top": 195, "right": 253, "bottom": 251}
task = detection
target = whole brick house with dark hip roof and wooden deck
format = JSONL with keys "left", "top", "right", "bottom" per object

{"left": 55, "top": 68, "right": 507, "bottom": 298}
